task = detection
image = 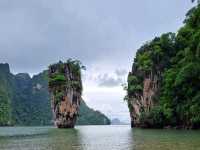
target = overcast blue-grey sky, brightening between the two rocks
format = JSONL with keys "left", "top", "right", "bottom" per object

{"left": 0, "top": 0, "right": 194, "bottom": 122}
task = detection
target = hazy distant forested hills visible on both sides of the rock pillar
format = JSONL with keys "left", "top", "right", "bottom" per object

{"left": 0, "top": 63, "right": 110, "bottom": 126}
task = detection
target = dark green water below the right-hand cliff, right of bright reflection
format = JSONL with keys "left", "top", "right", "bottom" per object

{"left": 133, "top": 129, "right": 200, "bottom": 150}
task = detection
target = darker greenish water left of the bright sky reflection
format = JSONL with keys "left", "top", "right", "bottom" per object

{"left": 0, "top": 127, "right": 80, "bottom": 150}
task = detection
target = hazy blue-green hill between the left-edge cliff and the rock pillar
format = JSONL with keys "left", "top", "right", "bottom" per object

{"left": 12, "top": 71, "right": 52, "bottom": 126}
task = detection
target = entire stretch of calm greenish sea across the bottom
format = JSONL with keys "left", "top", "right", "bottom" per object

{"left": 0, "top": 126, "right": 200, "bottom": 150}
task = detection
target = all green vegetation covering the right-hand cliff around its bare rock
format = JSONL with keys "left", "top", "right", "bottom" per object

{"left": 126, "top": 5, "right": 200, "bottom": 128}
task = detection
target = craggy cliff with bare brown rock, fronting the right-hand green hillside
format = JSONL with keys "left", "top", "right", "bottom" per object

{"left": 126, "top": 33, "right": 175, "bottom": 127}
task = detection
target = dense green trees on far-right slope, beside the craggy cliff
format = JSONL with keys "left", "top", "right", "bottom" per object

{"left": 161, "top": 7, "right": 200, "bottom": 128}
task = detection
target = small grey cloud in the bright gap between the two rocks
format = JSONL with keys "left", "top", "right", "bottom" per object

{"left": 97, "top": 74, "right": 122, "bottom": 87}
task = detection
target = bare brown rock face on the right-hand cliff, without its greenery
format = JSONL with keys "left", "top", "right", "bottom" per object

{"left": 128, "top": 70, "right": 160, "bottom": 127}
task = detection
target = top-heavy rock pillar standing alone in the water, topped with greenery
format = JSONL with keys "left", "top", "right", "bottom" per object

{"left": 49, "top": 59, "right": 84, "bottom": 128}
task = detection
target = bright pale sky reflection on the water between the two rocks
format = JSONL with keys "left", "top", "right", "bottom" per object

{"left": 76, "top": 126, "right": 133, "bottom": 150}
